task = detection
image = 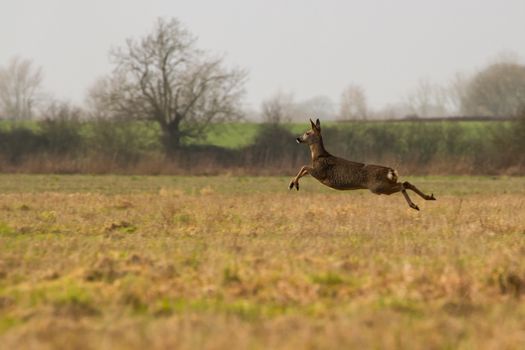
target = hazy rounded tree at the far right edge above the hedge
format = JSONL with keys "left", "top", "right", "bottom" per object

{"left": 461, "top": 61, "right": 525, "bottom": 116}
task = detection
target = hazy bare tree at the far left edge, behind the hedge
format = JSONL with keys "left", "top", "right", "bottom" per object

{"left": 0, "top": 57, "right": 42, "bottom": 119}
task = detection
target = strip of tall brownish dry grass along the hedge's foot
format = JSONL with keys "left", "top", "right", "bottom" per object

{"left": 0, "top": 154, "right": 525, "bottom": 176}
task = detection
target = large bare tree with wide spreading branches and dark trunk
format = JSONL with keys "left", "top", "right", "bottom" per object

{"left": 90, "top": 19, "right": 246, "bottom": 153}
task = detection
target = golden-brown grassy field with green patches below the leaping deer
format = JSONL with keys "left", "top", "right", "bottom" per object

{"left": 0, "top": 175, "right": 525, "bottom": 349}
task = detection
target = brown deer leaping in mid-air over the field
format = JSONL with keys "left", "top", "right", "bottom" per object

{"left": 288, "top": 119, "right": 436, "bottom": 210}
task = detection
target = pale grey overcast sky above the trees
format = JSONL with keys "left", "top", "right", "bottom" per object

{"left": 0, "top": 0, "right": 525, "bottom": 109}
